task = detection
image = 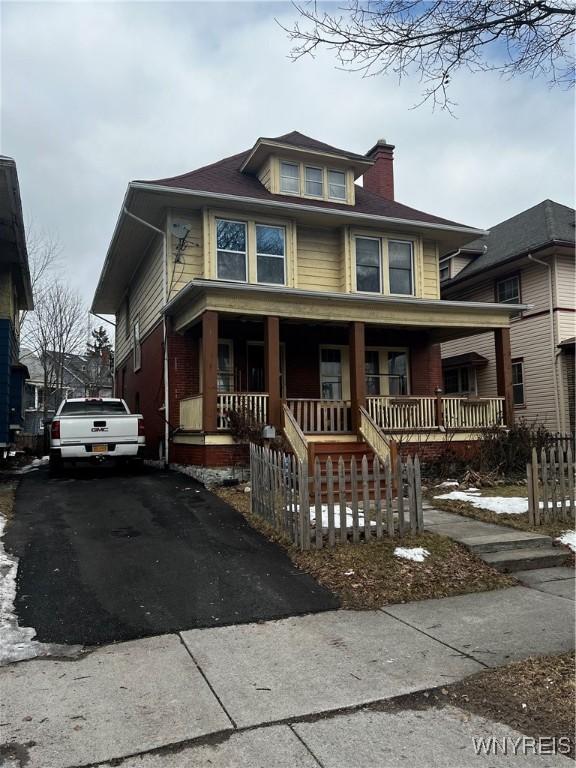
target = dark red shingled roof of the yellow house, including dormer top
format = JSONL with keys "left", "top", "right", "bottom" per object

{"left": 144, "top": 131, "right": 465, "bottom": 226}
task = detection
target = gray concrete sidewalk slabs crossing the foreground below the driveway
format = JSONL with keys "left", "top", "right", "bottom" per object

{"left": 0, "top": 587, "right": 574, "bottom": 768}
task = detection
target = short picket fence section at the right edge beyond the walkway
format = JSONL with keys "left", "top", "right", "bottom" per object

{"left": 526, "top": 443, "right": 576, "bottom": 525}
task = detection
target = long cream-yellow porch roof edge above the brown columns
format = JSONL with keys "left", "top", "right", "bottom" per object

{"left": 165, "top": 279, "right": 519, "bottom": 342}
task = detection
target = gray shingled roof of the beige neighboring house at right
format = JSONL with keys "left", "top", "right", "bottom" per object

{"left": 442, "top": 200, "right": 575, "bottom": 290}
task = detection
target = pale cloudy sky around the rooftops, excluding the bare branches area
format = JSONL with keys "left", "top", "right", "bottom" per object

{"left": 0, "top": 1, "right": 574, "bottom": 308}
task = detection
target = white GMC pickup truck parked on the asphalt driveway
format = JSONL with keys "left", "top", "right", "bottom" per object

{"left": 50, "top": 397, "right": 146, "bottom": 472}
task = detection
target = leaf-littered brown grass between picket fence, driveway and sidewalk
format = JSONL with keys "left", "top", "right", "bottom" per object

{"left": 215, "top": 488, "right": 517, "bottom": 610}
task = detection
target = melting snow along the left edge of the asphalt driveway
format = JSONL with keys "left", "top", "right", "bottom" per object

{"left": 0, "top": 492, "right": 82, "bottom": 666}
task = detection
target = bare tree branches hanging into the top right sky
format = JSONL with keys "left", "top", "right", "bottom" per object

{"left": 281, "top": 0, "right": 576, "bottom": 109}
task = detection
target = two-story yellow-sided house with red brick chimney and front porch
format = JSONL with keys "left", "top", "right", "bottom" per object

{"left": 92, "top": 131, "right": 516, "bottom": 476}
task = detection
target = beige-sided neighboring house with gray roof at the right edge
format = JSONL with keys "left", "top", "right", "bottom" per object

{"left": 440, "top": 200, "right": 576, "bottom": 433}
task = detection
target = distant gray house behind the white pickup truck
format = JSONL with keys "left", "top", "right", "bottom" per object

{"left": 20, "top": 349, "right": 113, "bottom": 435}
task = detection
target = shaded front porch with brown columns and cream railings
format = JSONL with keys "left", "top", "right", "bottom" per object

{"left": 173, "top": 310, "right": 512, "bottom": 439}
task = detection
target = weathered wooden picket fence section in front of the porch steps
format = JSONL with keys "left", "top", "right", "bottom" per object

{"left": 250, "top": 444, "right": 424, "bottom": 549}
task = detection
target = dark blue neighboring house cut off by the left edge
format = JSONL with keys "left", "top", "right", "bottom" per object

{"left": 0, "top": 155, "right": 33, "bottom": 458}
